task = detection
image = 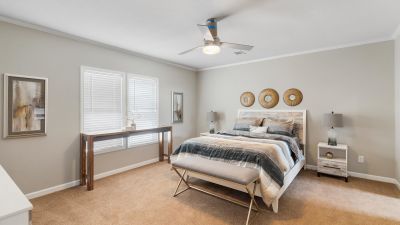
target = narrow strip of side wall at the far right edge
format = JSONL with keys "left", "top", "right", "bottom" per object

{"left": 395, "top": 35, "right": 400, "bottom": 183}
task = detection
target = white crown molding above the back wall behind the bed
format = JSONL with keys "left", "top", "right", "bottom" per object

{"left": 197, "top": 37, "right": 393, "bottom": 72}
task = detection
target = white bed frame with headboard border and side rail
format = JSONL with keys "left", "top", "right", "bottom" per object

{"left": 187, "top": 109, "right": 307, "bottom": 213}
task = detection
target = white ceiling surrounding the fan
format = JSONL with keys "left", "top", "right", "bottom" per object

{"left": 0, "top": 0, "right": 400, "bottom": 69}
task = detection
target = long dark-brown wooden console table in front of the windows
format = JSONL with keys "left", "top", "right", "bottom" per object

{"left": 80, "top": 126, "right": 172, "bottom": 191}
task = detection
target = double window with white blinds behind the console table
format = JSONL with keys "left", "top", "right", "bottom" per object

{"left": 81, "top": 67, "right": 159, "bottom": 153}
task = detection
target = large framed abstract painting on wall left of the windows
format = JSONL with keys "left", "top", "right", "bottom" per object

{"left": 3, "top": 74, "right": 48, "bottom": 138}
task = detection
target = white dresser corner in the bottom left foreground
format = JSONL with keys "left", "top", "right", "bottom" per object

{"left": 0, "top": 165, "right": 32, "bottom": 225}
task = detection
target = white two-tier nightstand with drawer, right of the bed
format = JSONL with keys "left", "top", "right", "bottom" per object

{"left": 317, "top": 142, "right": 348, "bottom": 182}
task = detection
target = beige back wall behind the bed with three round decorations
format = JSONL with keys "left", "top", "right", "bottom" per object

{"left": 197, "top": 41, "right": 395, "bottom": 177}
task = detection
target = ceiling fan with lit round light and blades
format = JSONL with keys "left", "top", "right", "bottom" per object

{"left": 179, "top": 18, "right": 254, "bottom": 55}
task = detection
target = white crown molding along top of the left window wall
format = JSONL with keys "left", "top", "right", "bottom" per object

{"left": 0, "top": 14, "right": 197, "bottom": 71}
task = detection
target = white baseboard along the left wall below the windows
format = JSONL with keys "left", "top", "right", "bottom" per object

{"left": 25, "top": 158, "right": 158, "bottom": 199}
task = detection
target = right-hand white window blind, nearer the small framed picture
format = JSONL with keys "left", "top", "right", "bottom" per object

{"left": 127, "top": 74, "right": 159, "bottom": 147}
